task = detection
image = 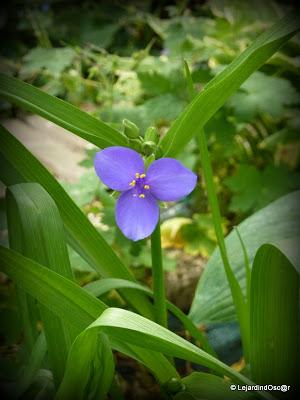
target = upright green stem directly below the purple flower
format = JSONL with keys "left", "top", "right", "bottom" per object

{"left": 151, "top": 222, "right": 168, "bottom": 328}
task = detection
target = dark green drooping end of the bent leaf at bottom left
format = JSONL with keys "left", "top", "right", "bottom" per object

{"left": 55, "top": 330, "right": 115, "bottom": 400}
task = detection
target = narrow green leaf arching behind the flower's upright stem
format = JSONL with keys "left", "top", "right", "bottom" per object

{"left": 84, "top": 278, "right": 217, "bottom": 357}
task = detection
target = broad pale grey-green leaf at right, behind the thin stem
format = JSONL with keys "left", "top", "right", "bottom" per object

{"left": 190, "top": 191, "right": 300, "bottom": 324}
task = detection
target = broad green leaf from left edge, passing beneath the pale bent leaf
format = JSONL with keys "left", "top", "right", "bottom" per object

{"left": 0, "top": 246, "right": 178, "bottom": 383}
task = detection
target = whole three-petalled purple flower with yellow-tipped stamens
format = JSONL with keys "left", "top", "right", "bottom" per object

{"left": 94, "top": 146, "right": 197, "bottom": 241}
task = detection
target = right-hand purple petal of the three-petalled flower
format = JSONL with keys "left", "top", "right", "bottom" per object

{"left": 146, "top": 158, "right": 197, "bottom": 201}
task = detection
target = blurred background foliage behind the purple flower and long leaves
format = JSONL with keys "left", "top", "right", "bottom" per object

{"left": 0, "top": 0, "right": 300, "bottom": 272}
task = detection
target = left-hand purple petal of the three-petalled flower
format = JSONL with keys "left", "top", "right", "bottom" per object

{"left": 94, "top": 146, "right": 145, "bottom": 191}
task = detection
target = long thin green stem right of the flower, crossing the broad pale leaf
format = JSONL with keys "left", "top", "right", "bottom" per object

{"left": 198, "top": 129, "right": 250, "bottom": 362}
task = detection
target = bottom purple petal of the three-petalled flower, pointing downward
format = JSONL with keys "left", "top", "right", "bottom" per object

{"left": 116, "top": 190, "right": 159, "bottom": 241}
